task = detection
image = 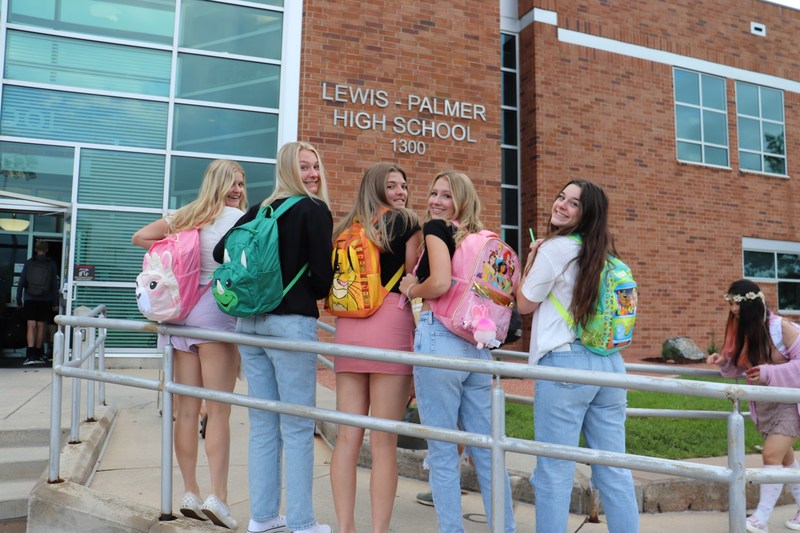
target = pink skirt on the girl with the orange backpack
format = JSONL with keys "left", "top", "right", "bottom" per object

{"left": 333, "top": 292, "right": 414, "bottom": 376}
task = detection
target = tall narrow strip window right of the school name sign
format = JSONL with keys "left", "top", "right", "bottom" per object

{"left": 500, "top": 33, "right": 521, "bottom": 252}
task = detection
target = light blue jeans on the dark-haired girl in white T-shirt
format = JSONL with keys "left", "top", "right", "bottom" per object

{"left": 533, "top": 342, "right": 639, "bottom": 533}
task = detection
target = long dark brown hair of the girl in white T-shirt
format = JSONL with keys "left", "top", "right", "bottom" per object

{"left": 546, "top": 179, "right": 617, "bottom": 326}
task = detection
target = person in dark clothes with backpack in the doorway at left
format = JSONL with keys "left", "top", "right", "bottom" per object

{"left": 17, "top": 240, "right": 59, "bottom": 366}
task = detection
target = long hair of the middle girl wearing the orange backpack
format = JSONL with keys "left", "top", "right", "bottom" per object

{"left": 333, "top": 163, "right": 417, "bottom": 252}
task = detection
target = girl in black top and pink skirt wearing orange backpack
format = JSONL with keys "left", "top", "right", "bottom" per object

{"left": 331, "top": 163, "right": 422, "bottom": 533}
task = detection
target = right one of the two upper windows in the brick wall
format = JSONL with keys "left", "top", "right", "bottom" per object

{"left": 736, "top": 82, "right": 786, "bottom": 176}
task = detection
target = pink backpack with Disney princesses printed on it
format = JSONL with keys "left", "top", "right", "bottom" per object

{"left": 428, "top": 230, "right": 520, "bottom": 348}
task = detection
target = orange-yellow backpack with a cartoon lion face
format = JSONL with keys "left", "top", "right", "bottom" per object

{"left": 325, "top": 215, "right": 403, "bottom": 318}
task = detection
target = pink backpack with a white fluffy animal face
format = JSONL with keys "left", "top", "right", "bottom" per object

{"left": 136, "top": 228, "right": 209, "bottom": 322}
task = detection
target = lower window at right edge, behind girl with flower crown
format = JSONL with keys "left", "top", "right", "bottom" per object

{"left": 742, "top": 238, "right": 800, "bottom": 314}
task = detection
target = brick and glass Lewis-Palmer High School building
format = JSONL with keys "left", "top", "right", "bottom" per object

{"left": 0, "top": 0, "right": 800, "bottom": 357}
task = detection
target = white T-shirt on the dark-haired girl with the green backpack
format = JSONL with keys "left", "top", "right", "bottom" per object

{"left": 522, "top": 237, "right": 581, "bottom": 365}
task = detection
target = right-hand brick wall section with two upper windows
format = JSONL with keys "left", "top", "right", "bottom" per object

{"left": 520, "top": 0, "right": 800, "bottom": 357}
